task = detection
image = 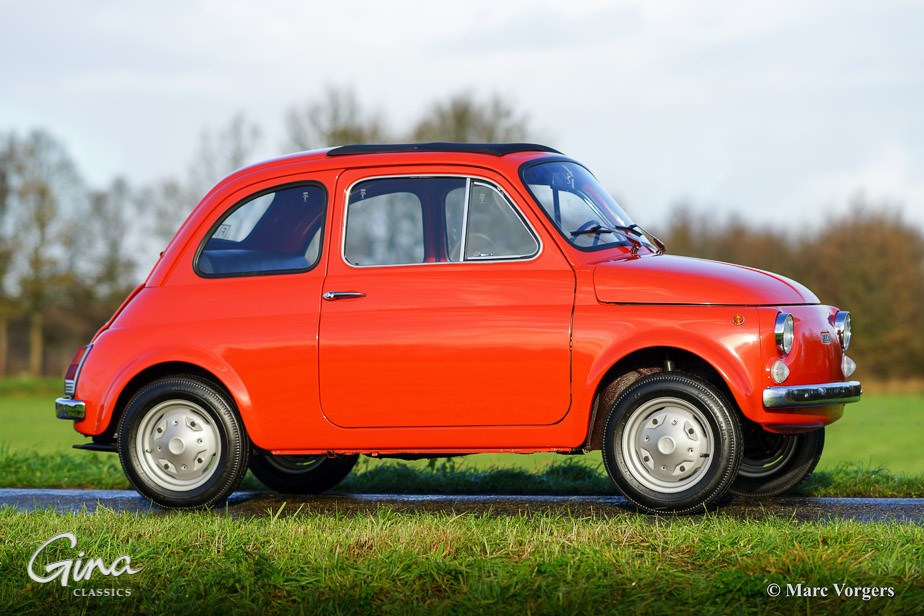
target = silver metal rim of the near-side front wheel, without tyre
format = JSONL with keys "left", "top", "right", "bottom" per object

{"left": 622, "top": 398, "right": 715, "bottom": 493}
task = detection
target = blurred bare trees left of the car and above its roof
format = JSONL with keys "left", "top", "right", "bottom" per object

{"left": 0, "top": 88, "right": 529, "bottom": 377}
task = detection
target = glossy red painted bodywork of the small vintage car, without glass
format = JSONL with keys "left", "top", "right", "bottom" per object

{"left": 68, "top": 152, "right": 856, "bottom": 454}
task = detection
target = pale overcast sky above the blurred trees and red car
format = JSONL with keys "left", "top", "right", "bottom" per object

{"left": 0, "top": 0, "right": 924, "bottom": 227}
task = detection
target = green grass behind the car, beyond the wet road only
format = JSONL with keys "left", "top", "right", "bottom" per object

{"left": 0, "top": 379, "right": 924, "bottom": 496}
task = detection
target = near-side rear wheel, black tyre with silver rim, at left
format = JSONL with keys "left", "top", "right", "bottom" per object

{"left": 119, "top": 376, "right": 250, "bottom": 509}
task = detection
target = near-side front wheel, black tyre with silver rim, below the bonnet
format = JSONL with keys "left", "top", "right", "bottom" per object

{"left": 603, "top": 372, "right": 742, "bottom": 515}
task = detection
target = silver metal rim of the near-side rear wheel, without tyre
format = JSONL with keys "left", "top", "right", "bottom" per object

{"left": 135, "top": 400, "right": 221, "bottom": 491}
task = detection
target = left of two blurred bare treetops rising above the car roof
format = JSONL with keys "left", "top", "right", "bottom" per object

{"left": 285, "top": 88, "right": 386, "bottom": 151}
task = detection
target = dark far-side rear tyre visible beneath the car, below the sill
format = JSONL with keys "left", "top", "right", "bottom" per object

{"left": 250, "top": 454, "right": 359, "bottom": 494}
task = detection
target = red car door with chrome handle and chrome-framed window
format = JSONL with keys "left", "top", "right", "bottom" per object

{"left": 319, "top": 170, "right": 575, "bottom": 427}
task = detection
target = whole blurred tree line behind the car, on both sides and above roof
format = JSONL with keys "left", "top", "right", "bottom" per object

{"left": 0, "top": 88, "right": 924, "bottom": 379}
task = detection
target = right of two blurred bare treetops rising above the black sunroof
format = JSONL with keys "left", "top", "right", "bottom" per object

{"left": 411, "top": 93, "right": 530, "bottom": 143}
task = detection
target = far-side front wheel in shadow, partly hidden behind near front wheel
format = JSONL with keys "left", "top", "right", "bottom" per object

{"left": 731, "top": 422, "right": 825, "bottom": 496}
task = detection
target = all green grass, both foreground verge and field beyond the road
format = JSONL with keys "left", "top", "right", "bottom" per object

{"left": 0, "top": 380, "right": 924, "bottom": 615}
